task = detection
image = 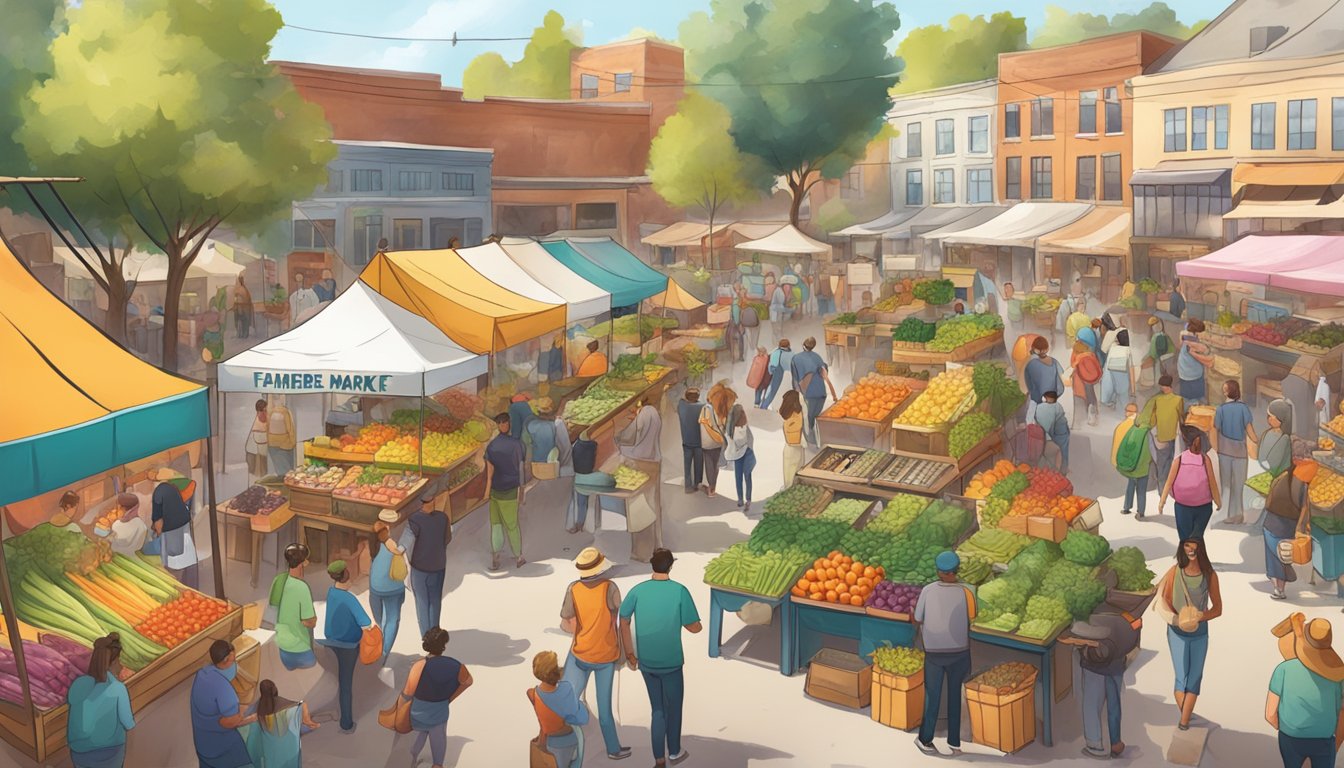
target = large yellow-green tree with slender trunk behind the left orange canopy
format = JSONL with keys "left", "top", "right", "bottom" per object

{"left": 16, "top": 0, "right": 336, "bottom": 369}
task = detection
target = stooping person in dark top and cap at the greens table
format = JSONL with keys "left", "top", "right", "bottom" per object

{"left": 1059, "top": 605, "right": 1142, "bottom": 760}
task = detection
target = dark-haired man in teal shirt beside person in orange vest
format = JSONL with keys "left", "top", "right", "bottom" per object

{"left": 621, "top": 547, "right": 702, "bottom": 765}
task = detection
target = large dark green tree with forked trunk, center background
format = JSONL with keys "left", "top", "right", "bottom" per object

{"left": 680, "top": 0, "right": 902, "bottom": 225}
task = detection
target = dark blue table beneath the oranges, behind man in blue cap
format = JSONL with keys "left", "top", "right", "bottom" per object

{"left": 784, "top": 597, "right": 1056, "bottom": 746}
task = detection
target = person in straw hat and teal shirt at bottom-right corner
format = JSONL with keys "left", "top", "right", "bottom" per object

{"left": 1265, "top": 613, "right": 1344, "bottom": 768}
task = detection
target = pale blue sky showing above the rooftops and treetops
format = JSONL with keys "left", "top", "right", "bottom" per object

{"left": 264, "top": 0, "right": 1230, "bottom": 86}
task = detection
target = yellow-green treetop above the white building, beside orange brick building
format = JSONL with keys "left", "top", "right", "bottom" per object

{"left": 895, "top": 11, "right": 1027, "bottom": 93}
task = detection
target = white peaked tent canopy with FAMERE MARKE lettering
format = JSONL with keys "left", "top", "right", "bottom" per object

{"left": 219, "top": 280, "right": 489, "bottom": 397}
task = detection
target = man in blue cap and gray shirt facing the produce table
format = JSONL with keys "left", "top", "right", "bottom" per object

{"left": 911, "top": 549, "right": 976, "bottom": 756}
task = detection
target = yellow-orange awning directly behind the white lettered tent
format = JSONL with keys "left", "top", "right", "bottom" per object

{"left": 360, "top": 249, "right": 566, "bottom": 354}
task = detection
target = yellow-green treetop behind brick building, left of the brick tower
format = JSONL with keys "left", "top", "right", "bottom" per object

{"left": 462, "top": 11, "right": 579, "bottom": 98}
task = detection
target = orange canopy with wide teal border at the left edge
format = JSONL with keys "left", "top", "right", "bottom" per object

{"left": 0, "top": 241, "right": 210, "bottom": 503}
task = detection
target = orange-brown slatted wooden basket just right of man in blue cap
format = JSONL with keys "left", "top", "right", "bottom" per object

{"left": 966, "top": 663, "right": 1036, "bottom": 753}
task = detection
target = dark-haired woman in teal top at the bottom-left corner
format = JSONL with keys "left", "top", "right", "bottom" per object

{"left": 66, "top": 632, "right": 136, "bottom": 768}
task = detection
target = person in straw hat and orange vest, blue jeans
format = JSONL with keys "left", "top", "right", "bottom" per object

{"left": 560, "top": 546, "right": 630, "bottom": 760}
